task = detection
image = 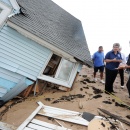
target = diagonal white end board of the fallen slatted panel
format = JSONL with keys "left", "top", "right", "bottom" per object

{"left": 17, "top": 102, "right": 43, "bottom": 130}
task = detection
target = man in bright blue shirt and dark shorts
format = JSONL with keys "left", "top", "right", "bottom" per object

{"left": 92, "top": 46, "right": 105, "bottom": 84}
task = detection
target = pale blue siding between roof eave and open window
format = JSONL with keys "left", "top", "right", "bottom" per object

{"left": 0, "top": 26, "right": 52, "bottom": 80}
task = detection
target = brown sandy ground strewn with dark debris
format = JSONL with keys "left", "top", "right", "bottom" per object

{"left": 1, "top": 66, "right": 130, "bottom": 130}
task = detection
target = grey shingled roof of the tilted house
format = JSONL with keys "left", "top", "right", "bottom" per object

{"left": 9, "top": 0, "right": 91, "bottom": 65}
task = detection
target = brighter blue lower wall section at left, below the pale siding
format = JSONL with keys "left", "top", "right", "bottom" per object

{"left": 0, "top": 68, "right": 33, "bottom": 100}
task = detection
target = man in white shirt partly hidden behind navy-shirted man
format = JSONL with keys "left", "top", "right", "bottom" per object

{"left": 119, "top": 47, "right": 126, "bottom": 89}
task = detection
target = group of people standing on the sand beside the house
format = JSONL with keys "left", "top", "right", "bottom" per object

{"left": 92, "top": 43, "right": 130, "bottom": 98}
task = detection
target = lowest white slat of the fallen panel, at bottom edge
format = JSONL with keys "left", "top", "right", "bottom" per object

{"left": 31, "top": 119, "right": 71, "bottom": 130}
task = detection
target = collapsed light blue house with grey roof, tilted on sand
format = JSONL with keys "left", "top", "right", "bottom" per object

{"left": 0, "top": 0, "right": 92, "bottom": 103}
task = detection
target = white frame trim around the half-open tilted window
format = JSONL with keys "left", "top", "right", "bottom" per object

{"left": 37, "top": 58, "right": 79, "bottom": 88}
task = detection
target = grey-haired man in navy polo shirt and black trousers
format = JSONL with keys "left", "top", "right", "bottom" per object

{"left": 105, "top": 43, "right": 122, "bottom": 94}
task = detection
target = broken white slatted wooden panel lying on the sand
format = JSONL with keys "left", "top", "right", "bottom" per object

{"left": 17, "top": 102, "right": 102, "bottom": 130}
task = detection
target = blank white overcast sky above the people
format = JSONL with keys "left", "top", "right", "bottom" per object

{"left": 52, "top": 0, "right": 130, "bottom": 56}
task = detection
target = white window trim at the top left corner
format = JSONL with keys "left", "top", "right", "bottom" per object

{"left": 0, "top": 1, "right": 12, "bottom": 27}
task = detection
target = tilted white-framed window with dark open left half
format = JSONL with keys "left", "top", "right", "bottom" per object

{"left": 38, "top": 54, "right": 79, "bottom": 88}
